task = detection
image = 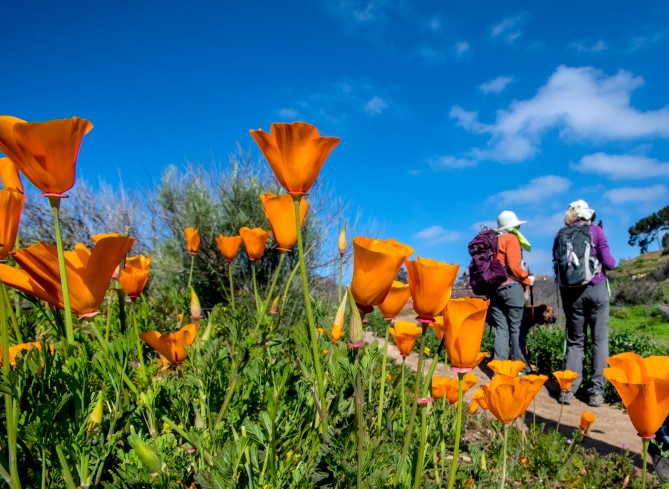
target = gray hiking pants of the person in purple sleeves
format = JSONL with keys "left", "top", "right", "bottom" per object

{"left": 560, "top": 281, "right": 609, "bottom": 395}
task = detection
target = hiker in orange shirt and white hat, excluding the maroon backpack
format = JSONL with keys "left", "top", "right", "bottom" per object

{"left": 489, "top": 211, "right": 534, "bottom": 374}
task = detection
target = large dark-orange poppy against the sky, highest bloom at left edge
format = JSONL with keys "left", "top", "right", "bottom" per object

{"left": 0, "top": 116, "right": 93, "bottom": 195}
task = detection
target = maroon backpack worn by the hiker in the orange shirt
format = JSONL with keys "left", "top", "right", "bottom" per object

{"left": 468, "top": 228, "right": 509, "bottom": 296}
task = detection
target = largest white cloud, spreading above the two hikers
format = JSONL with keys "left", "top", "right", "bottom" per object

{"left": 450, "top": 66, "right": 669, "bottom": 162}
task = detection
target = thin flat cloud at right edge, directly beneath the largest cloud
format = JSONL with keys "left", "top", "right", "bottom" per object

{"left": 570, "top": 153, "right": 669, "bottom": 180}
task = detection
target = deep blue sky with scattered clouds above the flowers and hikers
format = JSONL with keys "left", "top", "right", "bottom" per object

{"left": 0, "top": 0, "right": 669, "bottom": 273}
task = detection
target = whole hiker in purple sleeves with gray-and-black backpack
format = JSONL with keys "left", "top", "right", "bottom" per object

{"left": 553, "top": 200, "right": 616, "bottom": 407}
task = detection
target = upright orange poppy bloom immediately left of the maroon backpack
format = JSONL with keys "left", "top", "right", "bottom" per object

{"left": 406, "top": 256, "right": 460, "bottom": 322}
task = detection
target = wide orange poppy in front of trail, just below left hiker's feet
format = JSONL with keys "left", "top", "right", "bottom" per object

{"left": 481, "top": 375, "right": 534, "bottom": 424}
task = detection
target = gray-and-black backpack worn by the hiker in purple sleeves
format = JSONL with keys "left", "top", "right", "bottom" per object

{"left": 553, "top": 224, "right": 602, "bottom": 287}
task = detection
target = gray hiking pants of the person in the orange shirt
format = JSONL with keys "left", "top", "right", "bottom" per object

{"left": 490, "top": 282, "right": 529, "bottom": 369}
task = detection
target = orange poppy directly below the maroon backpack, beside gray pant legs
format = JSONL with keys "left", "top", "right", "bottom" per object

{"left": 443, "top": 297, "right": 490, "bottom": 371}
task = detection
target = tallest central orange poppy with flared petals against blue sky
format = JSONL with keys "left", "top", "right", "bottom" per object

{"left": 250, "top": 122, "right": 339, "bottom": 195}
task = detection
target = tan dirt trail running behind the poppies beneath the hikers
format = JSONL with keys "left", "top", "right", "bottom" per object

{"left": 365, "top": 332, "right": 650, "bottom": 467}
